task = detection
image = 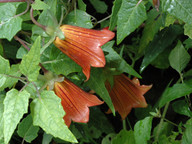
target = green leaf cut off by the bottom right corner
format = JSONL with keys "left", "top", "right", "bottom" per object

{"left": 181, "top": 119, "right": 192, "bottom": 144}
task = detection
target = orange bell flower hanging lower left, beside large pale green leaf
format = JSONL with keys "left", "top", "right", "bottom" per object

{"left": 53, "top": 78, "right": 103, "bottom": 127}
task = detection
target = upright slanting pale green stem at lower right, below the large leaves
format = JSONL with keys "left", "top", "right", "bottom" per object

{"left": 155, "top": 102, "right": 169, "bottom": 142}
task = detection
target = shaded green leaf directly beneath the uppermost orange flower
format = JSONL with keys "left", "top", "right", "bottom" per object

{"left": 50, "top": 46, "right": 81, "bottom": 76}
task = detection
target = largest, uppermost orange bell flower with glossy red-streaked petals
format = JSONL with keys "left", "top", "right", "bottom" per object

{"left": 54, "top": 25, "right": 115, "bottom": 80}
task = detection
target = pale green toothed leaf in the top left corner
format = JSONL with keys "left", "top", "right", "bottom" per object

{"left": 0, "top": 3, "right": 22, "bottom": 41}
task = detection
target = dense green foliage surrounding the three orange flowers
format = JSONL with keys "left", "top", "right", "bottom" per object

{"left": 0, "top": 0, "right": 192, "bottom": 144}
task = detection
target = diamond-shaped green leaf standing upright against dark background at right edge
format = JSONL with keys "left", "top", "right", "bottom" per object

{"left": 169, "top": 41, "right": 191, "bottom": 73}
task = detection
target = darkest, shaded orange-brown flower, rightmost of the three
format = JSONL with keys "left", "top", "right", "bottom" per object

{"left": 106, "top": 74, "right": 152, "bottom": 119}
